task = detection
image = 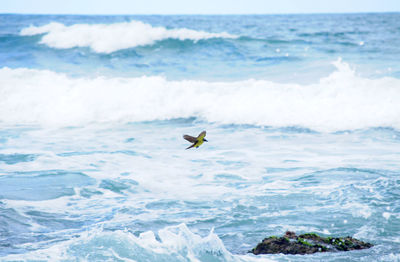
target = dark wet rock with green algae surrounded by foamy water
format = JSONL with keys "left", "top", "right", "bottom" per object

{"left": 249, "top": 231, "right": 373, "bottom": 255}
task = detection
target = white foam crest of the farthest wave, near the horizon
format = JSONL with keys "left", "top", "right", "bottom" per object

{"left": 21, "top": 21, "right": 237, "bottom": 53}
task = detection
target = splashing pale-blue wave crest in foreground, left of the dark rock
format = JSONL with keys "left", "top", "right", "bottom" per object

{"left": 4, "top": 224, "right": 266, "bottom": 261}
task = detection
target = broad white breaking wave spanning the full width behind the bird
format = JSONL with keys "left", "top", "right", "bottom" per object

{"left": 0, "top": 60, "right": 400, "bottom": 132}
